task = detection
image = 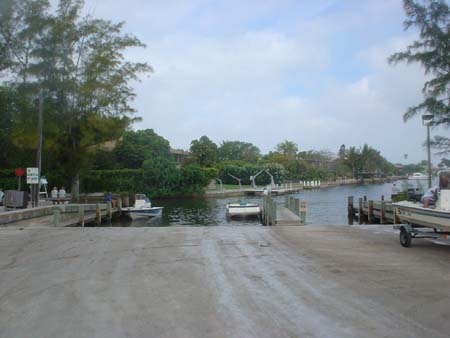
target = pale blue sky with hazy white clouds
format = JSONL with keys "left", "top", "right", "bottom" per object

{"left": 85, "top": 0, "right": 439, "bottom": 163}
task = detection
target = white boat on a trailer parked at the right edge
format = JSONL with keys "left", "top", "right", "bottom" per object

{"left": 392, "top": 171, "right": 450, "bottom": 247}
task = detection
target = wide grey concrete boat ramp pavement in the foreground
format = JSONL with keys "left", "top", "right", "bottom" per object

{"left": 0, "top": 226, "right": 450, "bottom": 338}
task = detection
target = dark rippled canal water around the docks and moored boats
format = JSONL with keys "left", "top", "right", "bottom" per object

{"left": 112, "top": 182, "right": 412, "bottom": 226}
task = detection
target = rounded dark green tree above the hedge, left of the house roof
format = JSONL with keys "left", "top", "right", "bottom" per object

{"left": 114, "top": 129, "right": 171, "bottom": 169}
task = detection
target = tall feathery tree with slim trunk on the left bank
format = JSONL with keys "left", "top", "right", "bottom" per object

{"left": 2, "top": 0, "right": 151, "bottom": 199}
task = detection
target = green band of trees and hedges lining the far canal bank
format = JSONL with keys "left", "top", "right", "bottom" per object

{"left": 0, "top": 129, "right": 425, "bottom": 198}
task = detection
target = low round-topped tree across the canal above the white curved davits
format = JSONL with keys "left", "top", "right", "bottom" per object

{"left": 217, "top": 141, "right": 261, "bottom": 163}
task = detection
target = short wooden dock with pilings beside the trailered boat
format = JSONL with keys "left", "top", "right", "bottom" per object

{"left": 347, "top": 196, "right": 398, "bottom": 225}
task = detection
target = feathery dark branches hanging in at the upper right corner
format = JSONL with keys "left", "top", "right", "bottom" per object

{"left": 389, "top": 0, "right": 450, "bottom": 151}
